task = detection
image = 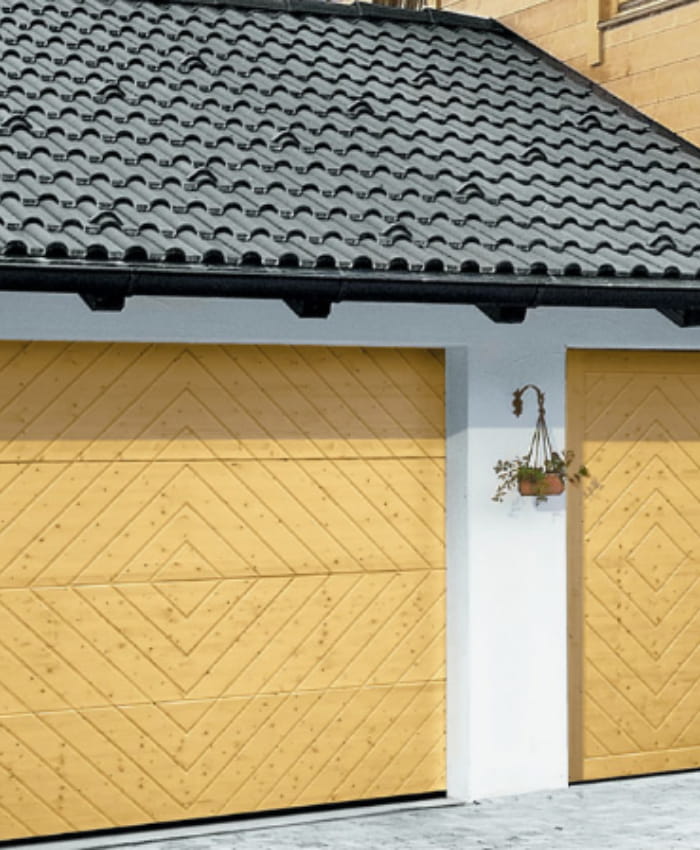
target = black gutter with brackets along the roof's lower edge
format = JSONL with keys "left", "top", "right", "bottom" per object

{"left": 0, "top": 260, "right": 700, "bottom": 327}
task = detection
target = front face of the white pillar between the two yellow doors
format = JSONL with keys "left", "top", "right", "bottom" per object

{"left": 461, "top": 336, "right": 568, "bottom": 799}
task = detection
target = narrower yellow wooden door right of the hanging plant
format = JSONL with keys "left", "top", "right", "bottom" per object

{"left": 568, "top": 351, "right": 700, "bottom": 779}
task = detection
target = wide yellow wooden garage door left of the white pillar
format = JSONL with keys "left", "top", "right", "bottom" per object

{"left": 0, "top": 343, "right": 445, "bottom": 839}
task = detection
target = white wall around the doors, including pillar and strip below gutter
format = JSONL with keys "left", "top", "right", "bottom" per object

{"left": 8, "top": 293, "right": 700, "bottom": 799}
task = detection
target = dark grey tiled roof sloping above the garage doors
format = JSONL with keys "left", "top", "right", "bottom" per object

{"left": 0, "top": 0, "right": 700, "bottom": 322}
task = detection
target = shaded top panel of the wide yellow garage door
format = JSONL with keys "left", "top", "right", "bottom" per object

{"left": 0, "top": 342, "right": 445, "bottom": 461}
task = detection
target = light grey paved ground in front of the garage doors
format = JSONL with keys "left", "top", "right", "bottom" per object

{"left": 105, "top": 772, "right": 700, "bottom": 850}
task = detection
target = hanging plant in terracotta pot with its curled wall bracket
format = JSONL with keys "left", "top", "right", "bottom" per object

{"left": 493, "top": 384, "right": 589, "bottom": 504}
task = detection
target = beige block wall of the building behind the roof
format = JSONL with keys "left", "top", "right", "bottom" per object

{"left": 442, "top": 0, "right": 700, "bottom": 145}
